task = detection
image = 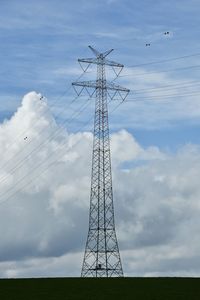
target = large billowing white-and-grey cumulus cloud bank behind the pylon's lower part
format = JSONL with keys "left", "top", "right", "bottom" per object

{"left": 0, "top": 92, "right": 200, "bottom": 277}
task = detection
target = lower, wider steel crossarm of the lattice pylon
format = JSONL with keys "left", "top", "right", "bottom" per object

{"left": 72, "top": 80, "right": 130, "bottom": 93}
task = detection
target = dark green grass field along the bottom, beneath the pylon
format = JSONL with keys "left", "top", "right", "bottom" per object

{"left": 0, "top": 278, "right": 200, "bottom": 300}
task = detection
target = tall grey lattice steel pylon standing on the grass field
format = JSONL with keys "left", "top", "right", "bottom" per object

{"left": 72, "top": 46, "right": 129, "bottom": 277}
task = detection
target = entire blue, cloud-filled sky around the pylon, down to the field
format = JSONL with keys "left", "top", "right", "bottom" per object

{"left": 0, "top": 0, "right": 200, "bottom": 278}
